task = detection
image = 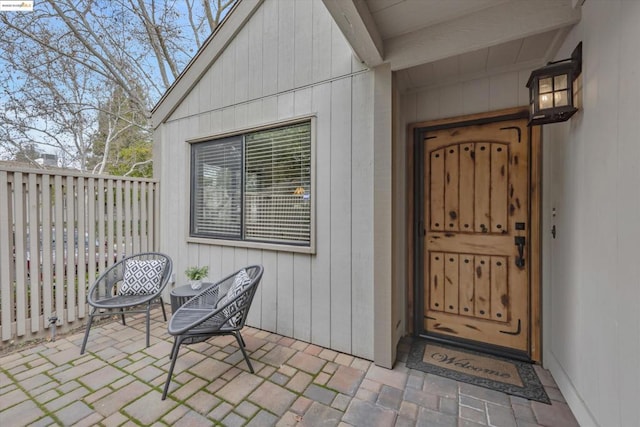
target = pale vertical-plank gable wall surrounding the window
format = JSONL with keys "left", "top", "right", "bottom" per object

{"left": 156, "top": 0, "right": 391, "bottom": 359}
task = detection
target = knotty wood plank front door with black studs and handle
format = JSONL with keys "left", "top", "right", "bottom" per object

{"left": 423, "top": 120, "right": 530, "bottom": 353}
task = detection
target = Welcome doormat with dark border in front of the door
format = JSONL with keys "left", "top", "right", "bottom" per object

{"left": 407, "top": 338, "right": 551, "bottom": 404}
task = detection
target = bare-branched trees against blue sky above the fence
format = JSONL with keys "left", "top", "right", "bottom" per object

{"left": 0, "top": 0, "right": 236, "bottom": 173}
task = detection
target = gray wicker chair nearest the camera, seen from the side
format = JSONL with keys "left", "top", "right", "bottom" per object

{"left": 162, "top": 265, "right": 264, "bottom": 400}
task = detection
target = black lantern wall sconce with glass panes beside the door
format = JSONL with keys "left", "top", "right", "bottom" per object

{"left": 527, "top": 42, "right": 582, "bottom": 126}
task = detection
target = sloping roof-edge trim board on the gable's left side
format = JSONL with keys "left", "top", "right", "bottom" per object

{"left": 151, "top": 0, "right": 264, "bottom": 129}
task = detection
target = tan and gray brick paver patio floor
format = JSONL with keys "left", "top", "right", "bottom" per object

{"left": 0, "top": 310, "right": 578, "bottom": 427}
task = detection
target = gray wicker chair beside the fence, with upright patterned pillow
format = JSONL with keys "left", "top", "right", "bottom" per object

{"left": 80, "top": 252, "right": 172, "bottom": 354}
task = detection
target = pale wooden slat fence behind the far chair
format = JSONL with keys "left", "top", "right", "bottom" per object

{"left": 0, "top": 165, "right": 159, "bottom": 347}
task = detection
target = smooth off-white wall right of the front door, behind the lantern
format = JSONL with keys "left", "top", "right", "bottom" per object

{"left": 543, "top": 0, "right": 640, "bottom": 426}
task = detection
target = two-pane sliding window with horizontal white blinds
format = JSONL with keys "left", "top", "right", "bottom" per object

{"left": 191, "top": 122, "right": 312, "bottom": 246}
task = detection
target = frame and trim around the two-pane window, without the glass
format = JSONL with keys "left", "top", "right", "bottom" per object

{"left": 185, "top": 115, "right": 317, "bottom": 254}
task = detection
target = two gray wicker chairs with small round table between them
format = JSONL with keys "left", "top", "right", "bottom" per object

{"left": 80, "top": 252, "right": 263, "bottom": 400}
